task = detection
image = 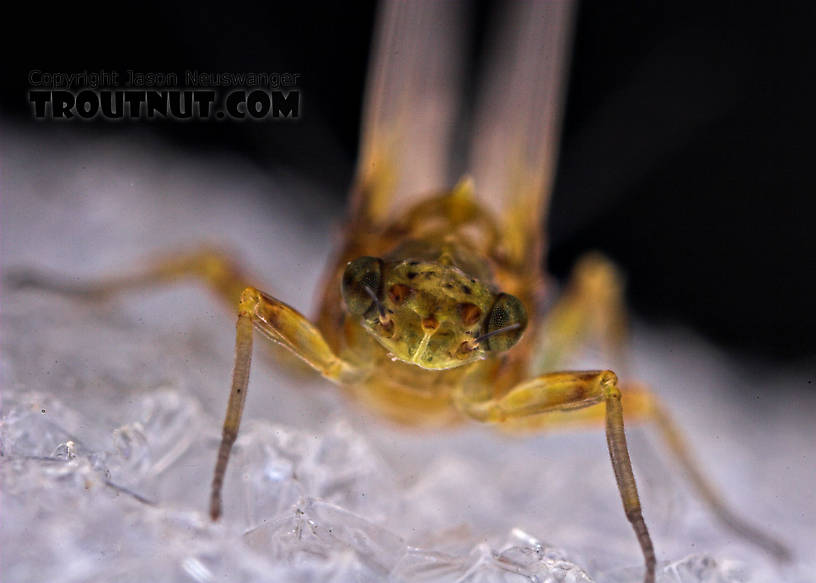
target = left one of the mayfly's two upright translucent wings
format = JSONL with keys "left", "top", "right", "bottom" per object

{"left": 353, "top": 0, "right": 464, "bottom": 226}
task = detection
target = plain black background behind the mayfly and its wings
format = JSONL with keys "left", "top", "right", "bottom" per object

{"left": 0, "top": 2, "right": 816, "bottom": 361}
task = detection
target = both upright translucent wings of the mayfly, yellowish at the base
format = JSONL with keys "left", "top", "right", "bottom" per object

{"left": 355, "top": 0, "right": 574, "bottom": 265}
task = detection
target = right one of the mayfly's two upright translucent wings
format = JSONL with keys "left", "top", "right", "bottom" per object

{"left": 469, "top": 0, "right": 574, "bottom": 269}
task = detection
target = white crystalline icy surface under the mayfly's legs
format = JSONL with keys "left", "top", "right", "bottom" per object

{"left": 0, "top": 128, "right": 816, "bottom": 583}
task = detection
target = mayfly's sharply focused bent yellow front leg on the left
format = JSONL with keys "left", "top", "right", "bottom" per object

{"left": 210, "top": 287, "right": 361, "bottom": 520}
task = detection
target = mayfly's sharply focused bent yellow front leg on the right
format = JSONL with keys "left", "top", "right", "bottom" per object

{"left": 456, "top": 370, "right": 657, "bottom": 583}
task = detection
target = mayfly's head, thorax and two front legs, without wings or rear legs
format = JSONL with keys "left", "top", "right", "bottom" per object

{"left": 215, "top": 172, "right": 656, "bottom": 581}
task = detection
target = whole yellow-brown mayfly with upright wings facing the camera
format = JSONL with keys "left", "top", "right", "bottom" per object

{"left": 11, "top": 0, "right": 787, "bottom": 582}
